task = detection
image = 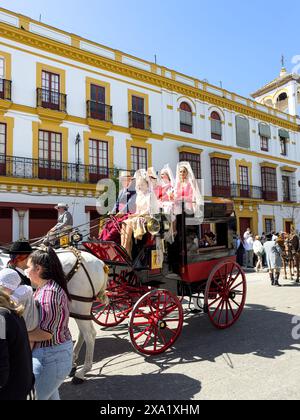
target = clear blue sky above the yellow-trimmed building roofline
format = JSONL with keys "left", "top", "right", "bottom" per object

{"left": 0, "top": 0, "right": 300, "bottom": 96}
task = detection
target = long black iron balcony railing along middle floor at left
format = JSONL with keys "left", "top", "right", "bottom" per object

{"left": 0, "top": 155, "right": 118, "bottom": 184}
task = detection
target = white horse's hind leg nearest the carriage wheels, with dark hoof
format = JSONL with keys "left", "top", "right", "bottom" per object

{"left": 73, "top": 320, "right": 97, "bottom": 385}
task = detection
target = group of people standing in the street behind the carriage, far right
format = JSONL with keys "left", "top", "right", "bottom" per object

{"left": 236, "top": 228, "right": 287, "bottom": 287}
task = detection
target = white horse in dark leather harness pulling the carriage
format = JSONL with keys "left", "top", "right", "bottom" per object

{"left": 0, "top": 249, "right": 108, "bottom": 385}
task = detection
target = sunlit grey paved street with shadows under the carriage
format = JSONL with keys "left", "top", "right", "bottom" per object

{"left": 61, "top": 273, "right": 300, "bottom": 401}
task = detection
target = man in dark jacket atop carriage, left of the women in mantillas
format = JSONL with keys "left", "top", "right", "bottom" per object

{"left": 112, "top": 171, "right": 136, "bottom": 214}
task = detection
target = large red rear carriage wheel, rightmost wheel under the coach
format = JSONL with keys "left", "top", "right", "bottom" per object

{"left": 204, "top": 261, "right": 247, "bottom": 329}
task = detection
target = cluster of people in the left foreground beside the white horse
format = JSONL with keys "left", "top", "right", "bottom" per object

{"left": 0, "top": 242, "right": 73, "bottom": 401}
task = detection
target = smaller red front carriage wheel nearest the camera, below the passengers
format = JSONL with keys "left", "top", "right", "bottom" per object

{"left": 129, "top": 290, "right": 183, "bottom": 356}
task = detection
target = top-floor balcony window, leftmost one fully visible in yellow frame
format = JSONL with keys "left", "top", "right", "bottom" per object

{"left": 42, "top": 71, "right": 60, "bottom": 110}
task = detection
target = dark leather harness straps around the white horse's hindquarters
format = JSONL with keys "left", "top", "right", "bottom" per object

{"left": 66, "top": 247, "right": 97, "bottom": 321}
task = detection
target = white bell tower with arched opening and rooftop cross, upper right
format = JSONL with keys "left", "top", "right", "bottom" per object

{"left": 251, "top": 56, "right": 300, "bottom": 116}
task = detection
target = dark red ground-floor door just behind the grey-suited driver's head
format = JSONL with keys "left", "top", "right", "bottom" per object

{"left": 29, "top": 209, "right": 58, "bottom": 239}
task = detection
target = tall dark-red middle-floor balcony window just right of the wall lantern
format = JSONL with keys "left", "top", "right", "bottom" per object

{"left": 89, "top": 140, "right": 109, "bottom": 182}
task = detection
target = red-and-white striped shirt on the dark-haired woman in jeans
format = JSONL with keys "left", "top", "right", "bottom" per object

{"left": 34, "top": 280, "right": 72, "bottom": 349}
